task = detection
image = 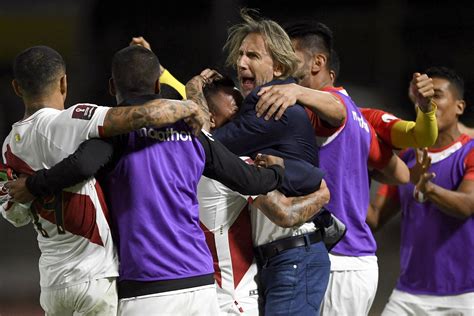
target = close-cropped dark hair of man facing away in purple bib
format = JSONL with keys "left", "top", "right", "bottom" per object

{"left": 112, "top": 45, "right": 160, "bottom": 94}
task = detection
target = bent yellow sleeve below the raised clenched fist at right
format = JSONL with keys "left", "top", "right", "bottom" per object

{"left": 390, "top": 101, "right": 438, "bottom": 148}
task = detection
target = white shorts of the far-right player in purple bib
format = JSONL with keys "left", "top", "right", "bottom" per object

{"left": 382, "top": 289, "right": 474, "bottom": 316}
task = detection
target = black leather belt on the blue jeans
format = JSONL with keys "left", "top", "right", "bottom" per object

{"left": 255, "top": 230, "right": 322, "bottom": 259}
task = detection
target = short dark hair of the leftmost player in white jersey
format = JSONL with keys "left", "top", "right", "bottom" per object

{"left": 13, "top": 46, "right": 66, "bottom": 96}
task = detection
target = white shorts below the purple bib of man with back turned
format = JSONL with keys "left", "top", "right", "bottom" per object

{"left": 118, "top": 284, "right": 219, "bottom": 316}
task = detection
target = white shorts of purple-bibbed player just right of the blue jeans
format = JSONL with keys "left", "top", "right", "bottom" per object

{"left": 321, "top": 255, "right": 379, "bottom": 316}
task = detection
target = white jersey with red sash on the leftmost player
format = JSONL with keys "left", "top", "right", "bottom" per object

{"left": 3, "top": 104, "right": 118, "bottom": 287}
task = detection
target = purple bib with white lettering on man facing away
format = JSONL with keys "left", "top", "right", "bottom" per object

{"left": 101, "top": 96, "right": 213, "bottom": 284}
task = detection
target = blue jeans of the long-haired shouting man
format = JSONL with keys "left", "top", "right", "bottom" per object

{"left": 258, "top": 242, "right": 331, "bottom": 316}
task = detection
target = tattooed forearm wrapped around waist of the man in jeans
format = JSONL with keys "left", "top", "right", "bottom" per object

{"left": 254, "top": 180, "right": 330, "bottom": 228}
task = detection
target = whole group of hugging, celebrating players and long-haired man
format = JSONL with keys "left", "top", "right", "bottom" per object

{"left": 1, "top": 10, "right": 474, "bottom": 315}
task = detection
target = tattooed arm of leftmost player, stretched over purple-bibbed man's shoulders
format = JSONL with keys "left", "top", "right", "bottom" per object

{"left": 102, "top": 99, "right": 203, "bottom": 137}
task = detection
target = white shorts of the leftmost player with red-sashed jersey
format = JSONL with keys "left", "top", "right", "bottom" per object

{"left": 40, "top": 278, "right": 118, "bottom": 316}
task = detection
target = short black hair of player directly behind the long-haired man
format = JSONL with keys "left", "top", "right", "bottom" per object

{"left": 284, "top": 20, "right": 333, "bottom": 57}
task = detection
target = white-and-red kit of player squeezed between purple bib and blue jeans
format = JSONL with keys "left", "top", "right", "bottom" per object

{"left": 198, "top": 176, "right": 258, "bottom": 315}
